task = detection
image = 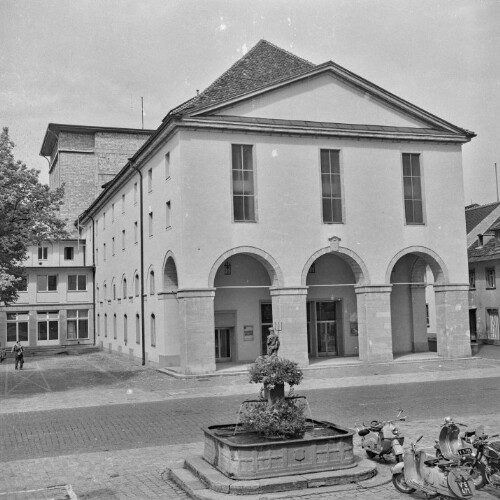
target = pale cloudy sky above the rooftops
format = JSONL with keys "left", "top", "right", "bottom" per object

{"left": 0, "top": 0, "right": 500, "bottom": 204}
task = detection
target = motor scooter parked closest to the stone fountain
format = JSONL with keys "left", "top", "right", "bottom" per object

{"left": 356, "top": 409, "right": 406, "bottom": 462}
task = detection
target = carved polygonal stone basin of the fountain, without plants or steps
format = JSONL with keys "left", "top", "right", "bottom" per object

{"left": 203, "top": 419, "right": 356, "bottom": 480}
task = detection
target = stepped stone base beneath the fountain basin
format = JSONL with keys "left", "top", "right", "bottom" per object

{"left": 169, "top": 456, "right": 391, "bottom": 500}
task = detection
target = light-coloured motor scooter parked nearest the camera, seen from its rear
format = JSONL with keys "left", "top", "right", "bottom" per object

{"left": 392, "top": 436, "right": 476, "bottom": 499}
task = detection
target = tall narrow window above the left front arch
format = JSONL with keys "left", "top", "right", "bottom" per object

{"left": 232, "top": 144, "right": 256, "bottom": 222}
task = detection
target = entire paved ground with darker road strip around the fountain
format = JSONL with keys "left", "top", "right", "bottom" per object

{"left": 0, "top": 348, "right": 500, "bottom": 500}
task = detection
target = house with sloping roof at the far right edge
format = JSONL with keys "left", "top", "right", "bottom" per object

{"left": 465, "top": 202, "right": 500, "bottom": 345}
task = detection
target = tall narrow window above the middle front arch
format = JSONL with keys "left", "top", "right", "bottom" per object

{"left": 320, "top": 149, "right": 343, "bottom": 224}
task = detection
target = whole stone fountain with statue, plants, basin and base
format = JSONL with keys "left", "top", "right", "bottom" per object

{"left": 170, "top": 331, "right": 376, "bottom": 496}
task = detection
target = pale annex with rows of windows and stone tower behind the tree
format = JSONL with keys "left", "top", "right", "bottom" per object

{"left": 0, "top": 123, "right": 153, "bottom": 349}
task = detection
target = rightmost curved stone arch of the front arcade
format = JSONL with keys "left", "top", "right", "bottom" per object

{"left": 385, "top": 246, "right": 450, "bottom": 285}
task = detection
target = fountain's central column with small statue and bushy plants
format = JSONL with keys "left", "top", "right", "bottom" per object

{"left": 241, "top": 331, "right": 306, "bottom": 439}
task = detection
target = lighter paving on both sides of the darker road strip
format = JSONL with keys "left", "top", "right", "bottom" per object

{"left": 0, "top": 346, "right": 500, "bottom": 500}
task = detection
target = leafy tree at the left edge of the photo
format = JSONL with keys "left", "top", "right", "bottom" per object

{"left": 0, "top": 127, "right": 68, "bottom": 304}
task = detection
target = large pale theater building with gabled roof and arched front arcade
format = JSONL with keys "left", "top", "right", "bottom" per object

{"left": 79, "top": 41, "right": 474, "bottom": 373}
